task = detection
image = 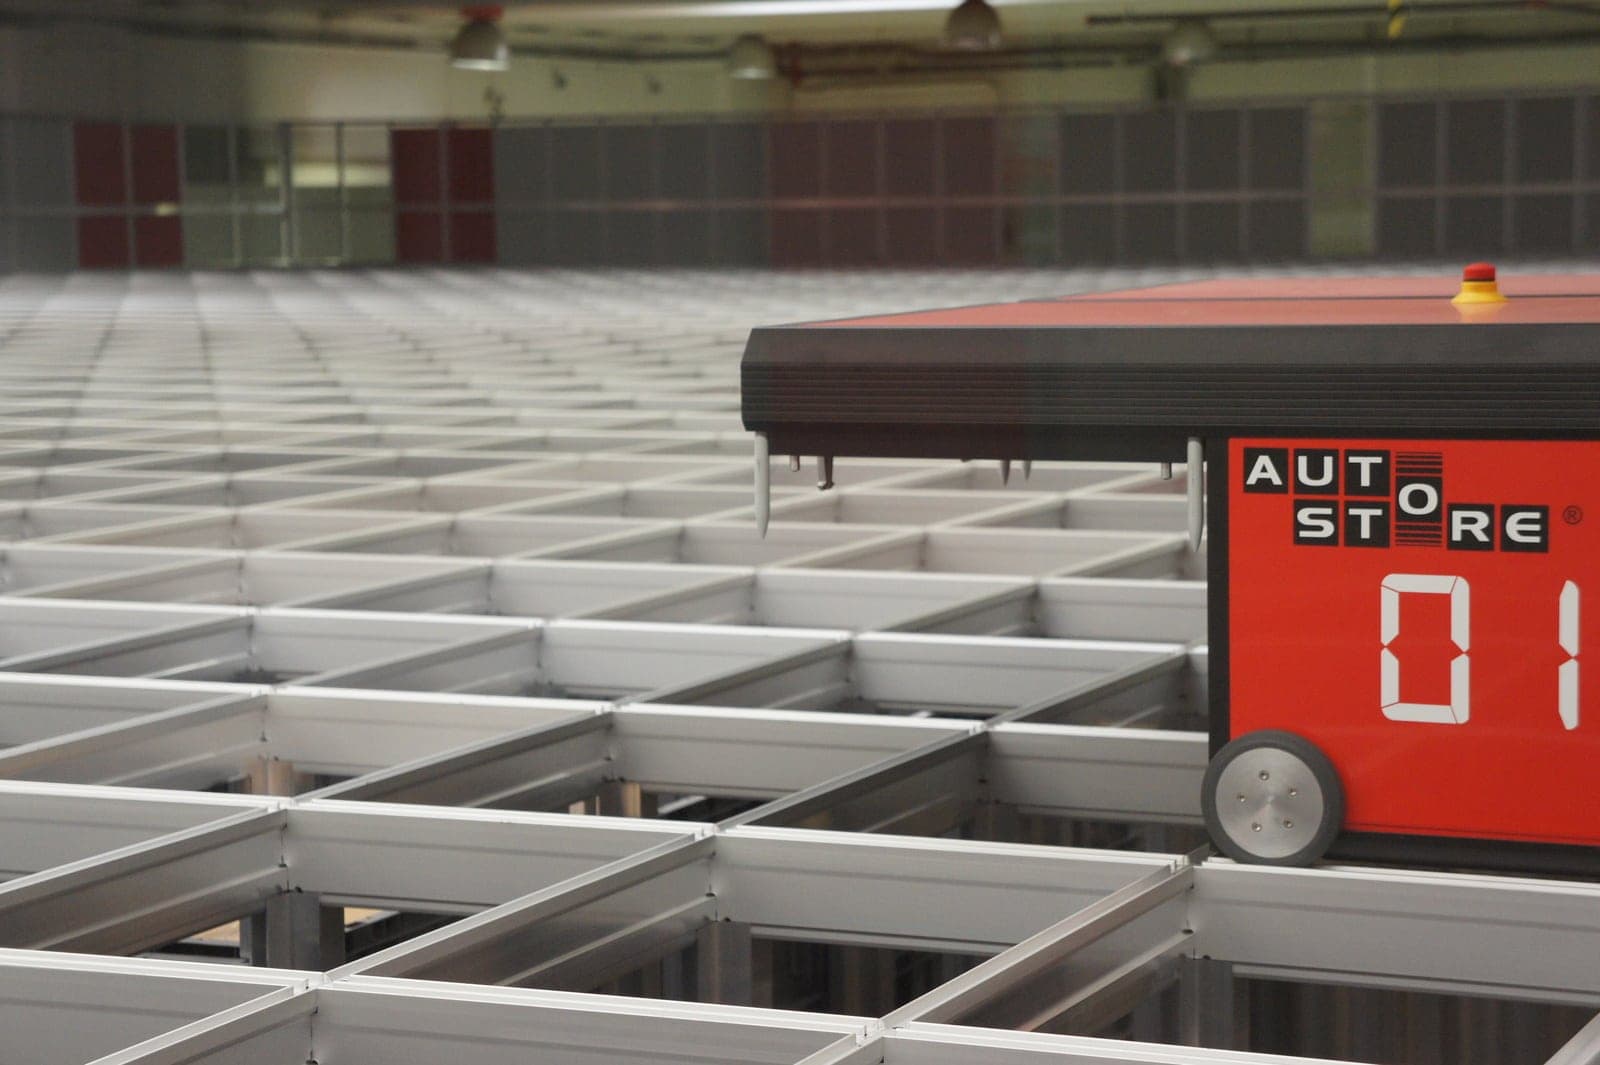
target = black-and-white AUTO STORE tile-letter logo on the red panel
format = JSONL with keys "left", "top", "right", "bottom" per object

{"left": 1243, "top": 448, "right": 1550, "bottom": 552}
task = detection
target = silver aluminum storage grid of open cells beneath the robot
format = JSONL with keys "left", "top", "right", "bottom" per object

{"left": 0, "top": 264, "right": 1600, "bottom": 1065}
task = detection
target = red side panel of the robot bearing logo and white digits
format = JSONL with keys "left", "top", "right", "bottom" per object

{"left": 1213, "top": 440, "right": 1600, "bottom": 846}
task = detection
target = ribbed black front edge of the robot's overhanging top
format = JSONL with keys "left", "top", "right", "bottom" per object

{"left": 744, "top": 325, "right": 1600, "bottom": 444}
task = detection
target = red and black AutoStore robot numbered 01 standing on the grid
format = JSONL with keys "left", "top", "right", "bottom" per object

{"left": 742, "top": 264, "right": 1600, "bottom": 872}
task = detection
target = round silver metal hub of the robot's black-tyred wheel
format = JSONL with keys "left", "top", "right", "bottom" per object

{"left": 1216, "top": 747, "right": 1325, "bottom": 859}
